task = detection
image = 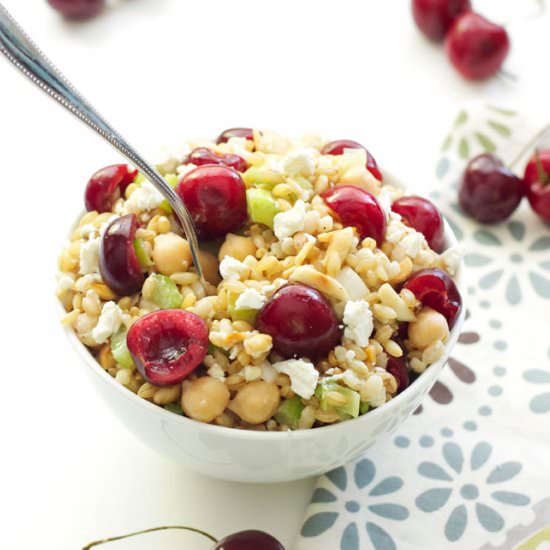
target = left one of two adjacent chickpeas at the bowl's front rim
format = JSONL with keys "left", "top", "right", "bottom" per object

{"left": 181, "top": 376, "right": 229, "bottom": 422}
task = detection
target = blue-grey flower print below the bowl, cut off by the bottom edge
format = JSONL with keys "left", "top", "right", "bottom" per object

{"left": 301, "top": 458, "right": 409, "bottom": 550}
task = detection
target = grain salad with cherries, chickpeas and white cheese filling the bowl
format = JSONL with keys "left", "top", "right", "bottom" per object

{"left": 57, "top": 128, "right": 461, "bottom": 431}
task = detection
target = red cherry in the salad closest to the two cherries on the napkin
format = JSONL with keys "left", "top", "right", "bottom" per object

{"left": 392, "top": 195, "right": 445, "bottom": 252}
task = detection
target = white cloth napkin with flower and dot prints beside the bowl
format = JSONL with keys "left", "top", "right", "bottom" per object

{"left": 295, "top": 104, "right": 550, "bottom": 550}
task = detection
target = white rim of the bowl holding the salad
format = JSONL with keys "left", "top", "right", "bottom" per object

{"left": 60, "top": 177, "right": 466, "bottom": 442}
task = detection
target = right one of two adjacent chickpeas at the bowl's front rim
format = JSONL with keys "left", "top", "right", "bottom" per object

{"left": 229, "top": 380, "right": 279, "bottom": 424}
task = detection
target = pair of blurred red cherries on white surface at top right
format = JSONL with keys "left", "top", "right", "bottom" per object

{"left": 412, "top": 0, "right": 510, "bottom": 80}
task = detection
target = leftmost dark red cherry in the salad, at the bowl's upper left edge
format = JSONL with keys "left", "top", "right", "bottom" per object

{"left": 84, "top": 164, "right": 137, "bottom": 213}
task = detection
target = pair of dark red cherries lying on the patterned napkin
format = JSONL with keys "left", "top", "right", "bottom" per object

{"left": 458, "top": 149, "right": 550, "bottom": 223}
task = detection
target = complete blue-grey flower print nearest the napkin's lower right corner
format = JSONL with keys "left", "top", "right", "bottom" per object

{"left": 415, "top": 441, "right": 530, "bottom": 542}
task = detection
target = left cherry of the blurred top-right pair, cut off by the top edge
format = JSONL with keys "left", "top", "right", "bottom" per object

{"left": 412, "top": 0, "right": 471, "bottom": 42}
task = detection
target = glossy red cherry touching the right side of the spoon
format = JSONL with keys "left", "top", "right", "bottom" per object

{"left": 176, "top": 164, "right": 247, "bottom": 239}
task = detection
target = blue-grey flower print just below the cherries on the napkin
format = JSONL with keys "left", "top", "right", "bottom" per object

{"left": 455, "top": 220, "right": 550, "bottom": 305}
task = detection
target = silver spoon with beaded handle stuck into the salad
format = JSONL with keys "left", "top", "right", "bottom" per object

{"left": 0, "top": 4, "right": 204, "bottom": 281}
